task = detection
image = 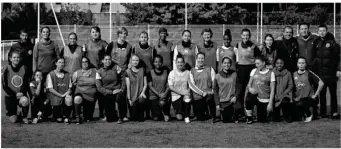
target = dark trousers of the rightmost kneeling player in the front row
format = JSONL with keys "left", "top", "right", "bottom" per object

{"left": 293, "top": 97, "right": 317, "bottom": 120}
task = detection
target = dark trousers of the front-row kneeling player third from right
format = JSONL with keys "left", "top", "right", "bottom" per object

{"left": 245, "top": 93, "right": 271, "bottom": 122}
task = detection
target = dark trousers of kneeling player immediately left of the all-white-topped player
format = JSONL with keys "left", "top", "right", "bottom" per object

{"left": 150, "top": 98, "right": 170, "bottom": 118}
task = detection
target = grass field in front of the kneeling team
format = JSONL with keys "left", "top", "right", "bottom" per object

{"left": 1, "top": 60, "right": 341, "bottom": 148}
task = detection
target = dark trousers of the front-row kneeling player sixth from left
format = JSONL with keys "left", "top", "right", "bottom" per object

{"left": 129, "top": 98, "right": 146, "bottom": 121}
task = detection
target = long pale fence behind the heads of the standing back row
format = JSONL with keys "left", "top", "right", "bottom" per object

{"left": 1, "top": 24, "right": 341, "bottom": 60}
